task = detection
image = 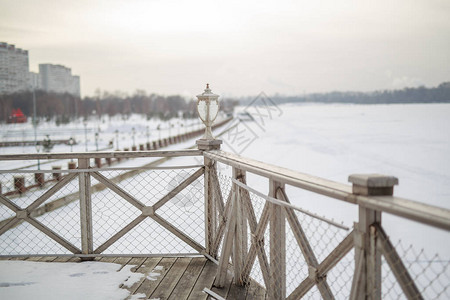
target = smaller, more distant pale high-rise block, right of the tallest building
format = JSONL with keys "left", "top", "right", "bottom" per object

{"left": 39, "top": 64, "right": 80, "bottom": 97}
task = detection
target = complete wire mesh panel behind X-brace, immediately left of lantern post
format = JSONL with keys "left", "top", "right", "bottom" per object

{"left": 92, "top": 168, "right": 205, "bottom": 254}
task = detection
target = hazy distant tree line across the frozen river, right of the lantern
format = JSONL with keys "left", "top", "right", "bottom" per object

{"left": 245, "top": 82, "right": 450, "bottom": 104}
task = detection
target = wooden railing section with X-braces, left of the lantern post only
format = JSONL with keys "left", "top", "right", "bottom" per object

{"left": 0, "top": 150, "right": 205, "bottom": 257}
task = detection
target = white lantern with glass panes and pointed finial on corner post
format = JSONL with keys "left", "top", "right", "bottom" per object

{"left": 197, "top": 84, "right": 219, "bottom": 140}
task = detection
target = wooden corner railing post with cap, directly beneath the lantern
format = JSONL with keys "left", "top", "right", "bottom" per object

{"left": 196, "top": 139, "right": 222, "bottom": 255}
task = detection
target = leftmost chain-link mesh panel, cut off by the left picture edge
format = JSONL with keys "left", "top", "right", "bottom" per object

{"left": 0, "top": 171, "right": 81, "bottom": 255}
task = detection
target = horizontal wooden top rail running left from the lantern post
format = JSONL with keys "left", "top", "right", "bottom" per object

{"left": 0, "top": 149, "right": 203, "bottom": 160}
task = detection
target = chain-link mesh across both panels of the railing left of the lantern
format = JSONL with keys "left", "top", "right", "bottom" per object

{"left": 0, "top": 166, "right": 205, "bottom": 255}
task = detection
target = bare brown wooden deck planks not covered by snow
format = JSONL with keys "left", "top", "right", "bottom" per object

{"left": 0, "top": 256, "right": 266, "bottom": 300}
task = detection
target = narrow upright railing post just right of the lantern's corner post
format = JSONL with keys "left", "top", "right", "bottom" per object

{"left": 232, "top": 167, "right": 248, "bottom": 286}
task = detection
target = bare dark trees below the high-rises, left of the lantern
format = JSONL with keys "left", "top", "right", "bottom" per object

{"left": 0, "top": 90, "right": 237, "bottom": 124}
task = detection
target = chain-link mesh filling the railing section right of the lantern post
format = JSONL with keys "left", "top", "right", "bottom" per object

{"left": 217, "top": 167, "right": 450, "bottom": 299}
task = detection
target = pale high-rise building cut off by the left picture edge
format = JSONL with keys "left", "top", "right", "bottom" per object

{"left": 0, "top": 42, "right": 30, "bottom": 94}
